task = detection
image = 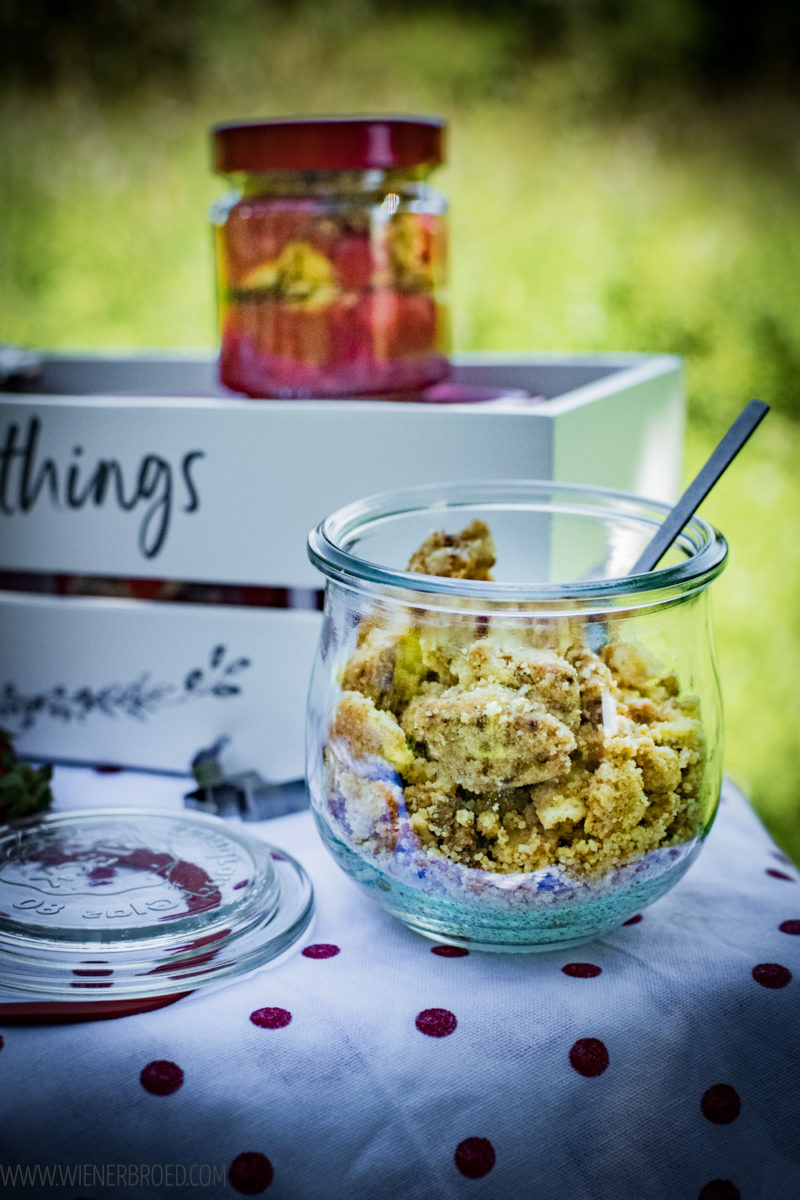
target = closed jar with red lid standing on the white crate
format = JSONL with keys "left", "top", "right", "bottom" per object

{"left": 212, "top": 116, "right": 449, "bottom": 397}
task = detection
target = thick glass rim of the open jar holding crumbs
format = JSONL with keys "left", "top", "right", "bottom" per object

{"left": 308, "top": 479, "right": 728, "bottom": 608}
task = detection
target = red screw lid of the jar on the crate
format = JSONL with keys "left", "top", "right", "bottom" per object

{"left": 212, "top": 116, "right": 445, "bottom": 175}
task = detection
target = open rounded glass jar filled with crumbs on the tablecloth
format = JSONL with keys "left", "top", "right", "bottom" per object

{"left": 307, "top": 481, "right": 727, "bottom": 950}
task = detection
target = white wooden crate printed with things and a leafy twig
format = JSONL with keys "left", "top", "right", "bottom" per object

{"left": 0, "top": 354, "right": 684, "bottom": 781}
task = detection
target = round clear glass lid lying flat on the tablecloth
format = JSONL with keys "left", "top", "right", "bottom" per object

{"left": 0, "top": 809, "right": 313, "bottom": 1003}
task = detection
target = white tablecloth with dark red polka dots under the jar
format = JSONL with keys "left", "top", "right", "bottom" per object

{"left": 0, "top": 768, "right": 800, "bottom": 1200}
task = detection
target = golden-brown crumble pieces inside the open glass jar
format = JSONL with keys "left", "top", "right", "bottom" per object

{"left": 327, "top": 522, "right": 705, "bottom": 874}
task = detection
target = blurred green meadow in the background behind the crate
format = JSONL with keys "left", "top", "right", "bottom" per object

{"left": 0, "top": 0, "right": 800, "bottom": 863}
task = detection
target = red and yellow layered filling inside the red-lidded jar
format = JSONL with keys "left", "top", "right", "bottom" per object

{"left": 217, "top": 197, "right": 447, "bottom": 397}
